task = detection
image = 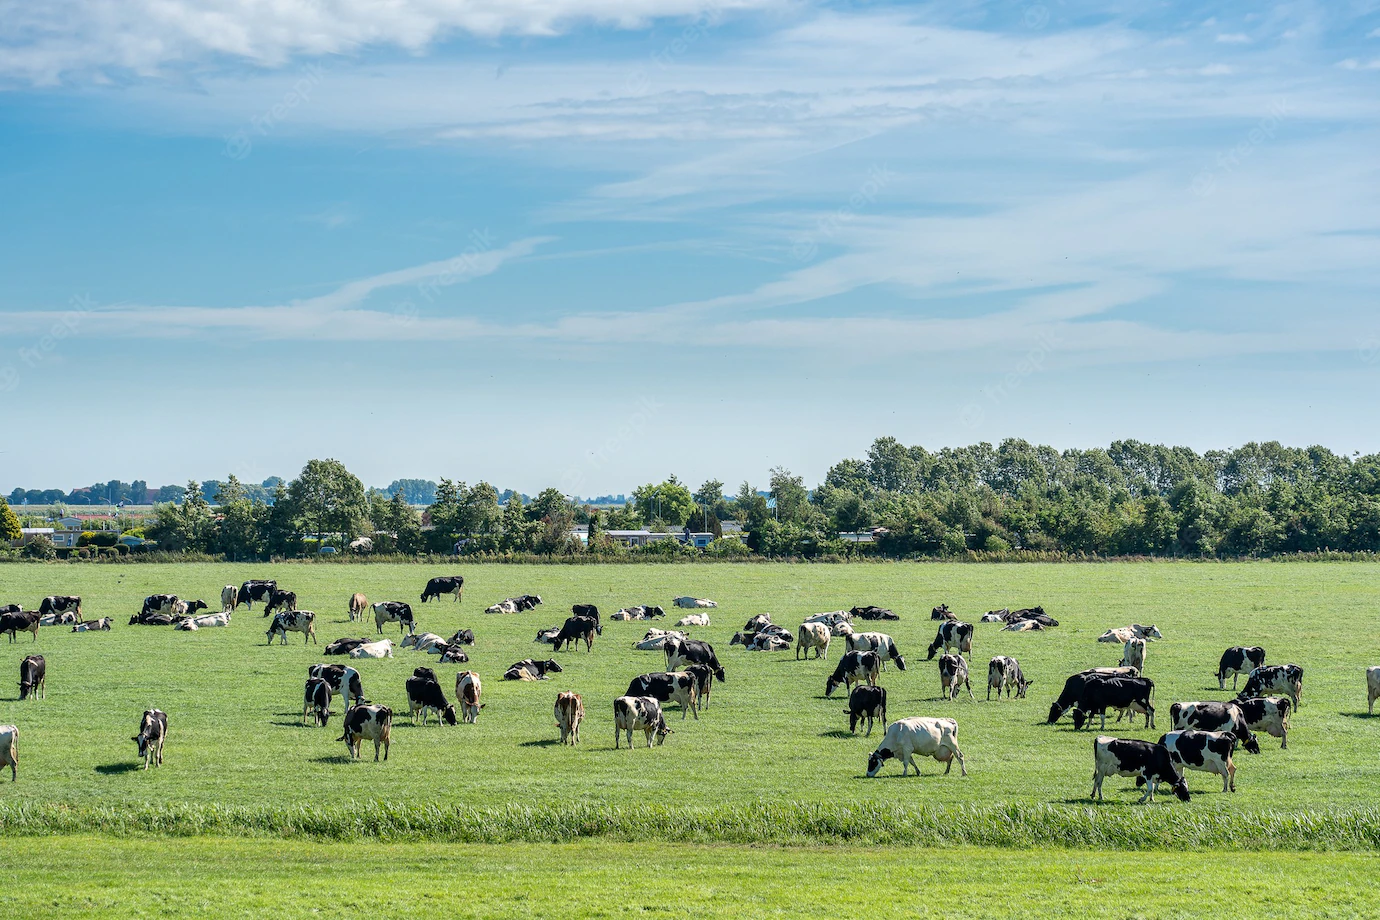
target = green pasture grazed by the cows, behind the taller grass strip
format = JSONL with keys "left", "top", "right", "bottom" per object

{"left": 0, "top": 563, "right": 1380, "bottom": 847}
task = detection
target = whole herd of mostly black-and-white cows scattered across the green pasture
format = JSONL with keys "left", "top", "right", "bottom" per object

{"left": 0, "top": 575, "right": 1380, "bottom": 801}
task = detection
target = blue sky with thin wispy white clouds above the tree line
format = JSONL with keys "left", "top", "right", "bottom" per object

{"left": 0, "top": 0, "right": 1380, "bottom": 495}
